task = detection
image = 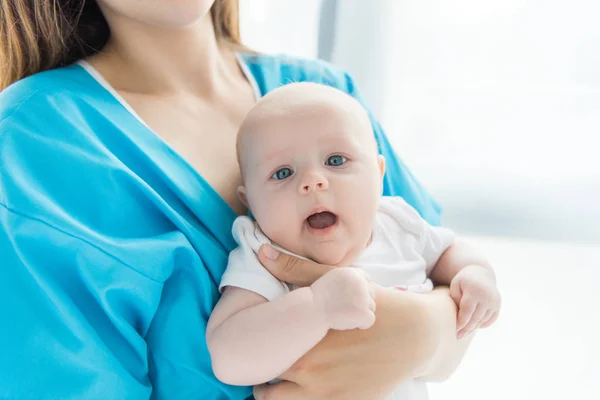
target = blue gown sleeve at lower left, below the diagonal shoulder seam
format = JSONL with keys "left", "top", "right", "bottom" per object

{"left": 0, "top": 204, "right": 161, "bottom": 400}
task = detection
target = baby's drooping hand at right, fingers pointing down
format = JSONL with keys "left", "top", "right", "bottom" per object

{"left": 450, "top": 265, "right": 501, "bottom": 339}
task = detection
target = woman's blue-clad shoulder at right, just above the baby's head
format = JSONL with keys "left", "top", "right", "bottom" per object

{"left": 241, "top": 53, "right": 354, "bottom": 94}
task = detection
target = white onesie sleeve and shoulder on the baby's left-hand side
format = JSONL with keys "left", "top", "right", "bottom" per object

{"left": 219, "top": 216, "right": 290, "bottom": 301}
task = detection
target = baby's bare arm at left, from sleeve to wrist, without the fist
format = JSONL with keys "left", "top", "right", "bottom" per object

{"left": 206, "top": 286, "right": 329, "bottom": 386}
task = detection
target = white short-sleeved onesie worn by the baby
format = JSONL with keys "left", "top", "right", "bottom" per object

{"left": 219, "top": 197, "right": 454, "bottom": 400}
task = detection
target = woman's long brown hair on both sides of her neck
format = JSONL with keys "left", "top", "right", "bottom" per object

{"left": 0, "top": 0, "right": 243, "bottom": 90}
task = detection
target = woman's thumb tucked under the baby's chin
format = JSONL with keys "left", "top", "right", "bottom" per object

{"left": 258, "top": 244, "right": 333, "bottom": 286}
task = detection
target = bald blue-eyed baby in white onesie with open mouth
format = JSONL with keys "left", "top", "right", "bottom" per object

{"left": 207, "top": 83, "right": 500, "bottom": 400}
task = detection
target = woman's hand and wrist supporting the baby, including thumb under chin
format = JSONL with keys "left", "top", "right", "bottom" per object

{"left": 255, "top": 246, "right": 456, "bottom": 400}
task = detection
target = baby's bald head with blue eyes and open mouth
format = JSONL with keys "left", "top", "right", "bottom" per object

{"left": 237, "top": 83, "right": 385, "bottom": 266}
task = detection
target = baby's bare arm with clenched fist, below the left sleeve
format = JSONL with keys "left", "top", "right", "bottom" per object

{"left": 206, "top": 268, "right": 375, "bottom": 386}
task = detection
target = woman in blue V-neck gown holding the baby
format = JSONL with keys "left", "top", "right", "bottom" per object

{"left": 0, "top": 0, "right": 467, "bottom": 400}
